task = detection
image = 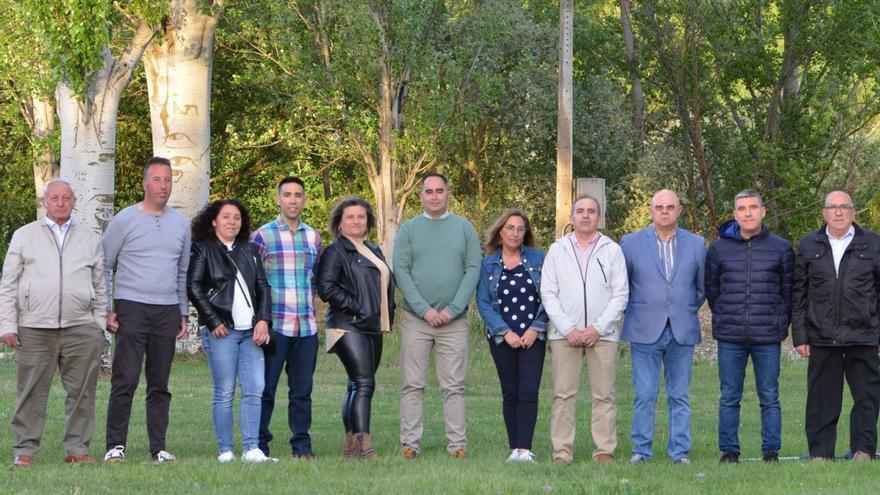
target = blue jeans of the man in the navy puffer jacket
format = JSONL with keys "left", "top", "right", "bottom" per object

{"left": 718, "top": 342, "right": 782, "bottom": 453}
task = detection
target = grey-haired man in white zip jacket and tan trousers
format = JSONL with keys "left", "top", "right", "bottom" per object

{"left": 541, "top": 195, "right": 629, "bottom": 464}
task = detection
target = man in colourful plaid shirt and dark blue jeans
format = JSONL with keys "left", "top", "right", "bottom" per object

{"left": 251, "top": 177, "right": 321, "bottom": 460}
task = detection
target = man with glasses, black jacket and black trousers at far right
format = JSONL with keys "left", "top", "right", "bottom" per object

{"left": 792, "top": 191, "right": 880, "bottom": 461}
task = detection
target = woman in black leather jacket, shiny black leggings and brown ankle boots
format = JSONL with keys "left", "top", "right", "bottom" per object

{"left": 317, "top": 197, "right": 394, "bottom": 459}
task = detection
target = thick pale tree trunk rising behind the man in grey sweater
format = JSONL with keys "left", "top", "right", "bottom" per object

{"left": 144, "top": 0, "right": 224, "bottom": 218}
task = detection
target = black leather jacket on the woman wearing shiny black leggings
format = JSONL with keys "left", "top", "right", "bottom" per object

{"left": 317, "top": 236, "right": 394, "bottom": 333}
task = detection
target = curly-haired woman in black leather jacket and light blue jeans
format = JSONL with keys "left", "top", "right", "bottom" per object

{"left": 186, "top": 199, "right": 272, "bottom": 463}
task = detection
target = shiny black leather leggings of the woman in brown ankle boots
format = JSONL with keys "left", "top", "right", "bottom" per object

{"left": 333, "top": 332, "right": 382, "bottom": 433}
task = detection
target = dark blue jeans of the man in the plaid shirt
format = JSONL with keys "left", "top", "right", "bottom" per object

{"left": 259, "top": 332, "right": 318, "bottom": 455}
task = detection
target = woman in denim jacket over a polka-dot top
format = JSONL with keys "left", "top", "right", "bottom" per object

{"left": 477, "top": 209, "right": 547, "bottom": 462}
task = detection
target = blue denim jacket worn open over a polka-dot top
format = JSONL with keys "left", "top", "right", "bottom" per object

{"left": 477, "top": 246, "right": 548, "bottom": 343}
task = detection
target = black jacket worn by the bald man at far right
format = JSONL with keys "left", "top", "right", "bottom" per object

{"left": 791, "top": 224, "right": 880, "bottom": 347}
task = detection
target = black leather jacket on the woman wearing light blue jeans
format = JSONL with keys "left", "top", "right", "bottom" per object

{"left": 186, "top": 237, "right": 272, "bottom": 330}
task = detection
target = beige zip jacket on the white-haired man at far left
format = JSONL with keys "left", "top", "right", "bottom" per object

{"left": 0, "top": 220, "right": 107, "bottom": 335}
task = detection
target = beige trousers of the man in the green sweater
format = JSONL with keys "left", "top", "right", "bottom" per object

{"left": 400, "top": 311, "right": 468, "bottom": 453}
